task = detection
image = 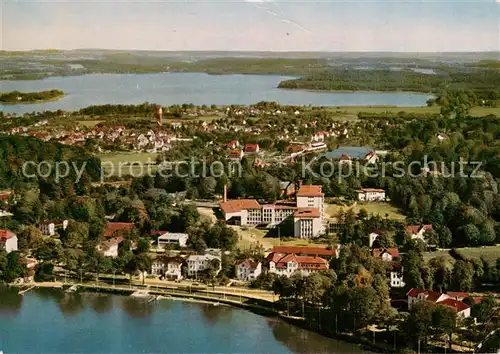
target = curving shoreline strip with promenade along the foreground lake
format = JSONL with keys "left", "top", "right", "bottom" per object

{"left": 8, "top": 281, "right": 394, "bottom": 353}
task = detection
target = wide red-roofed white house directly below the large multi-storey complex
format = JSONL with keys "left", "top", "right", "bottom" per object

{"left": 268, "top": 253, "right": 330, "bottom": 277}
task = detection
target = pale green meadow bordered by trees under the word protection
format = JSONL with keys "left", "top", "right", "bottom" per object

{"left": 98, "top": 152, "right": 158, "bottom": 176}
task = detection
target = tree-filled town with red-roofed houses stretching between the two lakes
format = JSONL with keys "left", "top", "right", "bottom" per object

{"left": 0, "top": 95, "right": 500, "bottom": 352}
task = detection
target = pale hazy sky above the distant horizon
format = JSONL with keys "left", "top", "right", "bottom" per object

{"left": 0, "top": 0, "right": 500, "bottom": 52}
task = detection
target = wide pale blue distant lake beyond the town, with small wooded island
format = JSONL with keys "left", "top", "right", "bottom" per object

{"left": 0, "top": 73, "right": 430, "bottom": 114}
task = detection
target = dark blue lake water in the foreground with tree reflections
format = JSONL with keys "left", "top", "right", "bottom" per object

{"left": 0, "top": 288, "right": 368, "bottom": 354}
